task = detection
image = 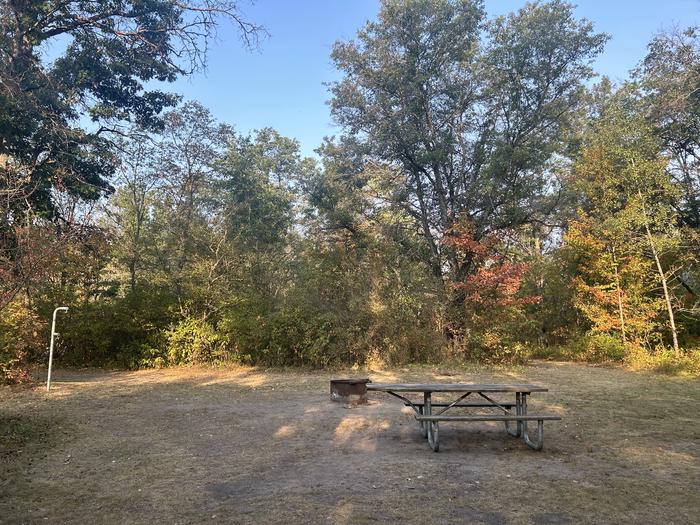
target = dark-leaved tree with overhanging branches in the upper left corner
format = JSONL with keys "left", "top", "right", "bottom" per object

{"left": 0, "top": 0, "right": 261, "bottom": 216}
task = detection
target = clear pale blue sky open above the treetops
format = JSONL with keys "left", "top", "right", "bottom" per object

{"left": 168, "top": 0, "right": 700, "bottom": 155}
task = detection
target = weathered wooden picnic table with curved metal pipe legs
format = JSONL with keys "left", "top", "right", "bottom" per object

{"left": 367, "top": 383, "right": 561, "bottom": 452}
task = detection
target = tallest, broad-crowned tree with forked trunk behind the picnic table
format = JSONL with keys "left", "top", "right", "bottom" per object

{"left": 331, "top": 0, "right": 607, "bottom": 282}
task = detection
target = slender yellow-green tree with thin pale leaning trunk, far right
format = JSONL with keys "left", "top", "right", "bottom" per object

{"left": 575, "top": 93, "right": 681, "bottom": 353}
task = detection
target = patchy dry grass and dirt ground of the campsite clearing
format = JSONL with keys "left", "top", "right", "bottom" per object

{"left": 0, "top": 363, "right": 700, "bottom": 524}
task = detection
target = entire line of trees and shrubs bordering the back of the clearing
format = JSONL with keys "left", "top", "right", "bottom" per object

{"left": 0, "top": 0, "right": 700, "bottom": 376}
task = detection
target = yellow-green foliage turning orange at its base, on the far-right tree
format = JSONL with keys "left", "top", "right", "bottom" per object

{"left": 566, "top": 89, "right": 684, "bottom": 351}
